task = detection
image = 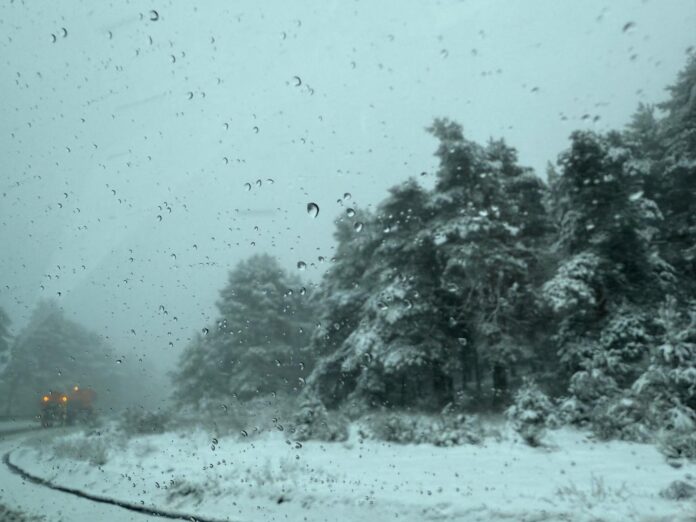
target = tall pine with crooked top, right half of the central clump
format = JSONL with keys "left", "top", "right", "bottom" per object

{"left": 430, "top": 120, "right": 551, "bottom": 403}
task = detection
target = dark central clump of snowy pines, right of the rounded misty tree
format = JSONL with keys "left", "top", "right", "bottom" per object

{"left": 309, "top": 120, "right": 552, "bottom": 409}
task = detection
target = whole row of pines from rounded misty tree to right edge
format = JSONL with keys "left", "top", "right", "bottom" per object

{"left": 176, "top": 56, "right": 696, "bottom": 446}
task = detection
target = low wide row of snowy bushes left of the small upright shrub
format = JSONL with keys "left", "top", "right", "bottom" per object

{"left": 361, "top": 412, "right": 485, "bottom": 446}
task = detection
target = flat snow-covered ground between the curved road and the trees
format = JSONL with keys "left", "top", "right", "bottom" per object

{"left": 6, "top": 422, "right": 696, "bottom": 522}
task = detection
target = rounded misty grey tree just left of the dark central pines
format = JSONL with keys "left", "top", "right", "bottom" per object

{"left": 174, "top": 255, "right": 316, "bottom": 403}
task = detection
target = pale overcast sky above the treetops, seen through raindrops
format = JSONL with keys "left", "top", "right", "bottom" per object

{"left": 0, "top": 0, "right": 696, "bottom": 374}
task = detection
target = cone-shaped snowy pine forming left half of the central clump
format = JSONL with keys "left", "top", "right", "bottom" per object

{"left": 310, "top": 180, "right": 452, "bottom": 409}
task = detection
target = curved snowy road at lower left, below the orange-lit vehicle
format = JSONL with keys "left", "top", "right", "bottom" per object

{"left": 0, "top": 422, "right": 164, "bottom": 522}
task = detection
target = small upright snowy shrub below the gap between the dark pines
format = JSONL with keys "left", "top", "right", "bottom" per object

{"left": 505, "top": 381, "right": 553, "bottom": 446}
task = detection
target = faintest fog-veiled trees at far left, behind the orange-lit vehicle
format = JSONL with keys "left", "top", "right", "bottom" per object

{"left": 0, "top": 301, "right": 122, "bottom": 414}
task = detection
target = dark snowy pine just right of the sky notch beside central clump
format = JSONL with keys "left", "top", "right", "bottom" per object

{"left": 544, "top": 132, "right": 668, "bottom": 420}
